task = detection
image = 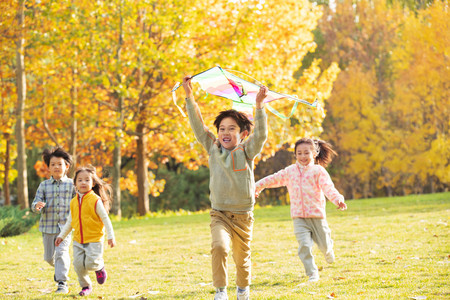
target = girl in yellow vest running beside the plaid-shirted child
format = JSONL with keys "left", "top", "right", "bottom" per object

{"left": 55, "top": 166, "right": 116, "bottom": 296}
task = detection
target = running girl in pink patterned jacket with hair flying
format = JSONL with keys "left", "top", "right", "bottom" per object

{"left": 256, "top": 138, "right": 347, "bottom": 282}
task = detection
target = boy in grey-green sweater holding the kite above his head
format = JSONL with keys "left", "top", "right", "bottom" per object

{"left": 183, "top": 76, "right": 268, "bottom": 300}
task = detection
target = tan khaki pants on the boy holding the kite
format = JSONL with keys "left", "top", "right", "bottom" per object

{"left": 210, "top": 209, "right": 254, "bottom": 287}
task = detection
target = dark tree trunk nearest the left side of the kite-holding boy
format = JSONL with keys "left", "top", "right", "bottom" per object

{"left": 136, "top": 123, "right": 149, "bottom": 216}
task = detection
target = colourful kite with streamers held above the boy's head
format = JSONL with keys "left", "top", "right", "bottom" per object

{"left": 172, "top": 66, "right": 317, "bottom": 119}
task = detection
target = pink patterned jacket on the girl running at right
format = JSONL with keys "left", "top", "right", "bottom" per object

{"left": 256, "top": 161, "right": 344, "bottom": 219}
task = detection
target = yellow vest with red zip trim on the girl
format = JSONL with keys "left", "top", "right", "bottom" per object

{"left": 70, "top": 190, "right": 105, "bottom": 244}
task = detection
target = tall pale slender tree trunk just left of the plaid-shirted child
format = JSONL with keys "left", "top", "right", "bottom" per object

{"left": 16, "top": 0, "right": 29, "bottom": 209}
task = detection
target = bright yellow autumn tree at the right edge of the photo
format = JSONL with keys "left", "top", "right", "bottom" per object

{"left": 387, "top": 1, "right": 450, "bottom": 193}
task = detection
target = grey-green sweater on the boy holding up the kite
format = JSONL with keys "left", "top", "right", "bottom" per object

{"left": 186, "top": 99, "right": 267, "bottom": 212}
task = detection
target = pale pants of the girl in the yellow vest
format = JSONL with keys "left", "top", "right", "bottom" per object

{"left": 73, "top": 241, "right": 104, "bottom": 287}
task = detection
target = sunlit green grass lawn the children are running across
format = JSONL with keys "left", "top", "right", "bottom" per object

{"left": 0, "top": 193, "right": 450, "bottom": 299}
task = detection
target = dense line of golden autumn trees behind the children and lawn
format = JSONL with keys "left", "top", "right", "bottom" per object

{"left": 0, "top": 0, "right": 450, "bottom": 215}
